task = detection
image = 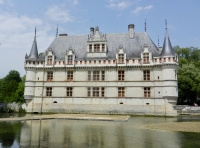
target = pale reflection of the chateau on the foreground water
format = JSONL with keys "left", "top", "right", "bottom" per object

{"left": 20, "top": 117, "right": 181, "bottom": 148}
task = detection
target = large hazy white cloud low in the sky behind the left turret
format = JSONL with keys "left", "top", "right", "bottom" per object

{"left": 0, "top": 11, "right": 55, "bottom": 78}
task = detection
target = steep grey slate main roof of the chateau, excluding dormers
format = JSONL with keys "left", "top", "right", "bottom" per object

{"left": 35, "top": 32, "right": 160, "bottom": 60}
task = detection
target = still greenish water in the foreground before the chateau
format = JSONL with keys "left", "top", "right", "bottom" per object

{"left": 0, "top": 114, "right": 200, "bottom": 148}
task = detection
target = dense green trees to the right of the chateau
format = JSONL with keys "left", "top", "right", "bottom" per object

{"left": 176, "top": 46, "right": 200, "bottom": 105}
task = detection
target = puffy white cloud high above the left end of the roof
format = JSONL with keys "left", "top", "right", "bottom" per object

{"left": 45, "top": 6, "right": 73, "bottom": 23}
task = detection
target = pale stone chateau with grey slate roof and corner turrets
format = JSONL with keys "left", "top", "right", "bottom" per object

{"left": 24, "top": 24, "right": 178, "bottom": 116}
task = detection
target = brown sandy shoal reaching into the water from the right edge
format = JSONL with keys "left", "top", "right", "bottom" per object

{"left": 143, "top": 122, "right": 200, "bottom": 133}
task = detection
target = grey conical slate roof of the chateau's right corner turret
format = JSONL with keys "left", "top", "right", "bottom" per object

{"left": 161, "top": 31, "right": 174, "bottom": 56}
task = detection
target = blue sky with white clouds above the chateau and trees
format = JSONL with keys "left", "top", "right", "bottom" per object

{"left": 0, "top": 0, "right": 200, "bottom": 78}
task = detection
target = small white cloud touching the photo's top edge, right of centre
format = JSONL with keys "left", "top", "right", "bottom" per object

{"left": 106, "top": 0, "right": 131, "bottom": 9}
